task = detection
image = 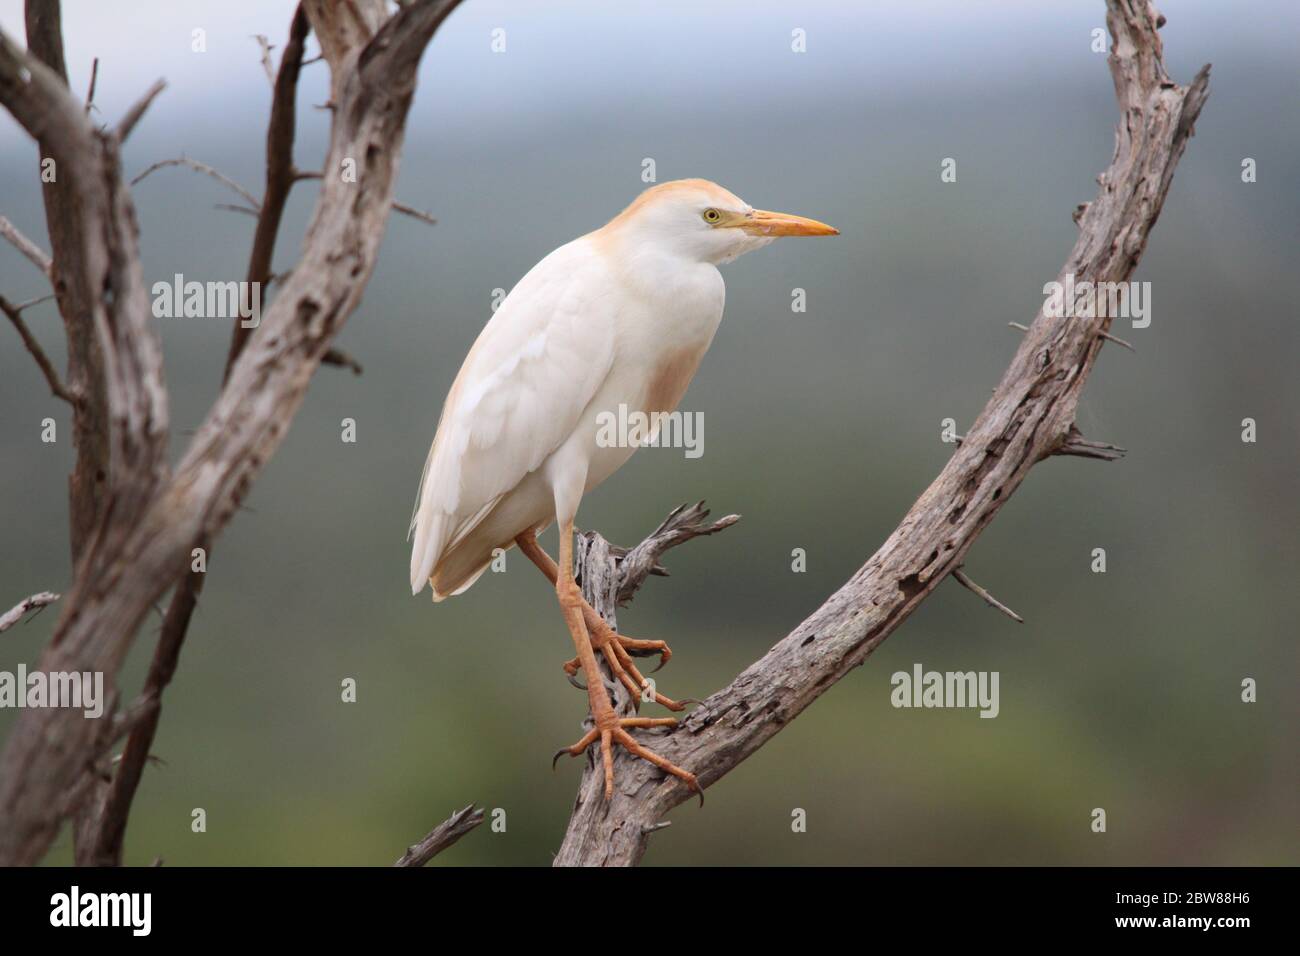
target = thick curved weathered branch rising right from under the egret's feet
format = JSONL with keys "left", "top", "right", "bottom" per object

{"left": 555, "top": 0, "right": 1209, "bottom": 865}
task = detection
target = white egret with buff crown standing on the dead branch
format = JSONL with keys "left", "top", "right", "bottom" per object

{"left": 411, "top": 179, "right": 839, "bottom": 799}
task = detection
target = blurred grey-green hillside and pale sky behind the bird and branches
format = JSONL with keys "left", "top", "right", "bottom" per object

{"left": 0, "top": 0, "right": 1300, "bottom": 864}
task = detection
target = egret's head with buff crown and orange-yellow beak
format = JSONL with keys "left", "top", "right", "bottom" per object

{"left": 606, "top": 179, "right": 840, "bottom": 264}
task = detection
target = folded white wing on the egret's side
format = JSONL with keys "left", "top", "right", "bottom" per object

{"left": 411, "top": 239, "right": 616, "bottom": 594}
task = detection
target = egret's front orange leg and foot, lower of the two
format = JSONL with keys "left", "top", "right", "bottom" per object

{"left": 555, "top": 522, "right": 703, "bottom": 800}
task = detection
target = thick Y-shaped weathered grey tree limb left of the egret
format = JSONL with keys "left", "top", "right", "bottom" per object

{"left": 0, "top": 0, "right": 459, "bottom": 865}
